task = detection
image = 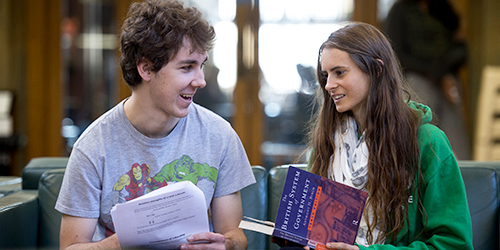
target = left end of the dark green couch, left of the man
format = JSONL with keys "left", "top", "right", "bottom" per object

{"left": 0, "top": 157, "right": 68, "bottom": 249}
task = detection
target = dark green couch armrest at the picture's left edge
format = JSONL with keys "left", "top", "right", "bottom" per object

{"left": 0, "top": 190, "right": 38, "bottom": 249}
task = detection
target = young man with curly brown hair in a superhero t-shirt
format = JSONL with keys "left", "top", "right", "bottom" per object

{"left": 56, "top": 1, "right": 255, "bottom": 249}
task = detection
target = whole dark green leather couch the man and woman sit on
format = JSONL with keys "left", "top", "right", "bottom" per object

{"left": 0, "top": 157, "right": 500, "bottom": 250}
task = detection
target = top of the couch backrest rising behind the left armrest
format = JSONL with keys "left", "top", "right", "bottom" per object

{"left": 22, "top": 157, "right": 68, "bottom": 189}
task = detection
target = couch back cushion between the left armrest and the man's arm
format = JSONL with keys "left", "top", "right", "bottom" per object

{"left": 38, "top": 169, "right": 65, "bottom": 249}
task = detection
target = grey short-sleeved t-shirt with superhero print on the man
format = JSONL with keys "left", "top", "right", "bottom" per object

{"left": 56, "top": 100, "right": 255, "bottom": 241}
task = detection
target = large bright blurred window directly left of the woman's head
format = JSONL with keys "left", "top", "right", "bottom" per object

{"left": 259, "top": 0, "right": 354, "bottom": 167}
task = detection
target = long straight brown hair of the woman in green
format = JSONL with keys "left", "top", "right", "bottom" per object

{"left": 309, "top": 22, "right": 421, "bottom": 243}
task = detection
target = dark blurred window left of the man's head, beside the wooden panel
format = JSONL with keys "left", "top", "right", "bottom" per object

{"left": 61, "top": 0, "right": 119, "bottom": 153}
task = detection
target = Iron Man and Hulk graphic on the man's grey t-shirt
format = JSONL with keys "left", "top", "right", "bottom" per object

{"left": 100, "top": 155, "right": 219, "bottom": 237}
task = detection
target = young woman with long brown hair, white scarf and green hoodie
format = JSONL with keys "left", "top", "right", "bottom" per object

{"left": 309, "top": 23, "right": 472, "bottom": 250}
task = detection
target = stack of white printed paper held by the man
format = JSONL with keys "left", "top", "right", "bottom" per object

{"left": 111, "top": 181, "right": 210, "bottom": 249}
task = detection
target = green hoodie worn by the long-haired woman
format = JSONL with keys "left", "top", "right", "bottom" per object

{"left": 359, "top": 102, "right": 473, "bottom": 250}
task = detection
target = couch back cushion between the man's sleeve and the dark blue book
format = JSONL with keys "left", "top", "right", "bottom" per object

{"left": 241, "top": 166, "right": 268, "bottom": 250}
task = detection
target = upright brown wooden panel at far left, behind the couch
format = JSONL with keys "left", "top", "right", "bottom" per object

{"left": 24, "top": 0, "right": 62, "bottom": 168}
